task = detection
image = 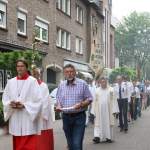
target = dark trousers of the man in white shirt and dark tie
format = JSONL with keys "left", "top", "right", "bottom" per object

{"left": 118, "top": 98, "right": 128, "bottom": 129}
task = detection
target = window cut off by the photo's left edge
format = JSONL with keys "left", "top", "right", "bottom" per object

{"left": 0, "top": 2, "right": 6, "bottom": 28}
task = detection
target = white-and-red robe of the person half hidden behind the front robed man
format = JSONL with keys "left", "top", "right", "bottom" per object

{"left": 38, "top": 80, "right": 54, "bottom": 150}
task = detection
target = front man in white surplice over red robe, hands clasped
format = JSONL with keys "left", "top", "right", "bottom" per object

{"left": 2, "top": 59, "right": 42, "bottom": 150}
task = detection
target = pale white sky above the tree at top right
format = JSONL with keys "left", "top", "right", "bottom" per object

{"left": 112, "top": 0, "right": 150, "bottom": 20}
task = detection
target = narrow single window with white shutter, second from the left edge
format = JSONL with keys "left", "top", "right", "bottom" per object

{"left": 17, "top": 11, "right": 27, "bottom": 35}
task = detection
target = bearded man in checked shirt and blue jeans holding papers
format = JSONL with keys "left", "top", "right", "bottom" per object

{"left": 56, "top": 64, "right": 92, "bottom": 150}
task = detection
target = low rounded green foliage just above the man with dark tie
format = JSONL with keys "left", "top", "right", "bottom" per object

{"left": 109, "top": 67, "right": 136, "bottom": 83}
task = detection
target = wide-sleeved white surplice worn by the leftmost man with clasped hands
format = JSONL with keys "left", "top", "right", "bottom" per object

{"left": 2, "top": 76, "right": 42, "bottom": 136}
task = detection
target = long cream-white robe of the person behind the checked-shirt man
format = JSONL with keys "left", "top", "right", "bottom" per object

{"left": 92, "top": 87, "right": 119, "bottom": 141}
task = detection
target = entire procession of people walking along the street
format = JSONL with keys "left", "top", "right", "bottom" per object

{"left": 2, "top": 59, "right": 150, "bottom": 150}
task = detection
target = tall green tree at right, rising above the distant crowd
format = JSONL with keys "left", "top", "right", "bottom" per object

{"left": 115, "top": 12, "right": 150, "bottom": 77}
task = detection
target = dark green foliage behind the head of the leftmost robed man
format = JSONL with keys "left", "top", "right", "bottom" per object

{"left": 0, "top": 50, "right": 42, "bottom": 76}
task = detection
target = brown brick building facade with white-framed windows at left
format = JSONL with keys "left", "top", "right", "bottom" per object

{"left": 0, "top": 0, "right": 115, "bottom": 90}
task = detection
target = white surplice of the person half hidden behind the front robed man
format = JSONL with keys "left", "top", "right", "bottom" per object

{"left": 40, "top": 82, "right": 52, "bottom": 130}
